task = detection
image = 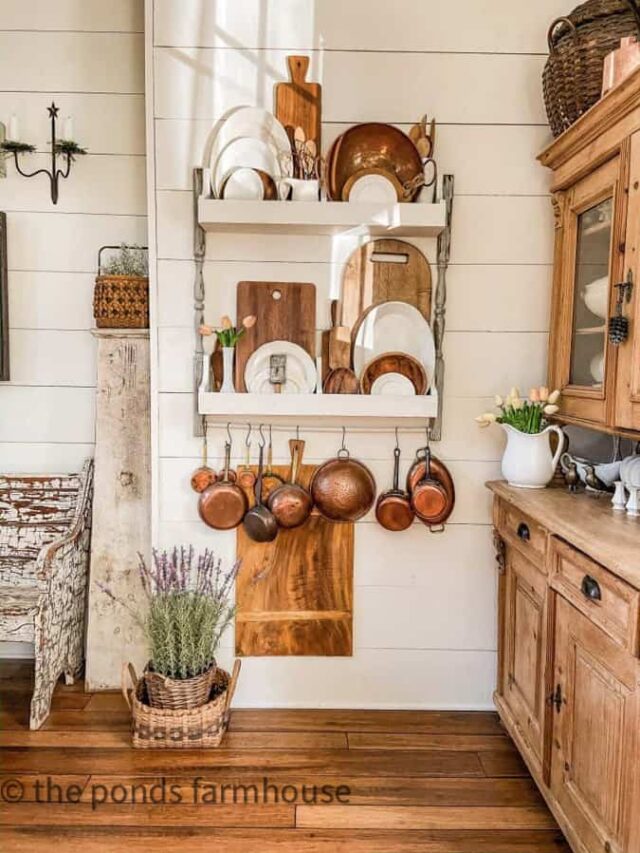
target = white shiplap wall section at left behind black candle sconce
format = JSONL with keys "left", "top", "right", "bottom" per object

{"left": 0, "top": 0, "right": 147, "bottom": 472}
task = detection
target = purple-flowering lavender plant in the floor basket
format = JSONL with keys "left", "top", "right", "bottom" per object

{"left": 98, "top": 546, "right": 240, "bottom": 679}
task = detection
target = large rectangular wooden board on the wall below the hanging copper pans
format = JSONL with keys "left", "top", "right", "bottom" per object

{"left": 235, "top": 465, "right": 354, "bottom": 656}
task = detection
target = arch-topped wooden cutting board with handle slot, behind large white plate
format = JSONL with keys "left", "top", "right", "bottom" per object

{"left": 338, "top": 240, "right": 431, "bottom": 332}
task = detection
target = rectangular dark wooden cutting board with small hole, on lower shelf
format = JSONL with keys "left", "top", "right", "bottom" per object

{"left": 236, "top": 281, "right": 316, "bottom": 391}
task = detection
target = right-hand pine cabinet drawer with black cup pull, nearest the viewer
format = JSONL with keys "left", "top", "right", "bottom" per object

{"left": 551, "top": 537, "right": 640, "bottom": 655}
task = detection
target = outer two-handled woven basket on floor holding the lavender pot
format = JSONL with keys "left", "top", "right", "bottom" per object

{"left": 122, "top": 660, "right": 240, "bottom": 749}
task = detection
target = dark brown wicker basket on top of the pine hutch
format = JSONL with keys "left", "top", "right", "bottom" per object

{"left": 542, "top": 0, "right": 640, "bottom": 136}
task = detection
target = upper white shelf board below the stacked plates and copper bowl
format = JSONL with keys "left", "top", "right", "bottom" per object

{"left": 198, "top": 198, "right": 446, "bottom": 237}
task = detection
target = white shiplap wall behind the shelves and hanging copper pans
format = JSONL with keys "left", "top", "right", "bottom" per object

{"left": 147, "top": 0, "right": 566, "bottom": 708}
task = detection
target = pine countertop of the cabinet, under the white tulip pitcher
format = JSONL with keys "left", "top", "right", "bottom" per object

{"left": 487, "top": 480, "right": 640, "bottom": 589}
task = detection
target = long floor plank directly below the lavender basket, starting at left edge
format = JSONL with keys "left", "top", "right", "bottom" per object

{"left": 2, "top": 747, "right": 485, "bottom": 776}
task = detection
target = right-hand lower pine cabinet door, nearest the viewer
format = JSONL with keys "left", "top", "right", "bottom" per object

{"left": 551, "top": 598, "right": 640, "bottom": 853}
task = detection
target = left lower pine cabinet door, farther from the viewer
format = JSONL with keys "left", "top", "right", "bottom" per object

{"left": 503, "top": 547, "right": 547, "bottom": 765}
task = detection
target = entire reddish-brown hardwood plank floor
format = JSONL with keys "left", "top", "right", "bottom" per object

{"left": 0, "top": 661, "right": 570, "bottom": 853}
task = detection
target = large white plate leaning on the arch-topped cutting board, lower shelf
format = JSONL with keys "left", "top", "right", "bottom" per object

{"left": 353, "top": 302, "right": 436, "bottom": 390}
